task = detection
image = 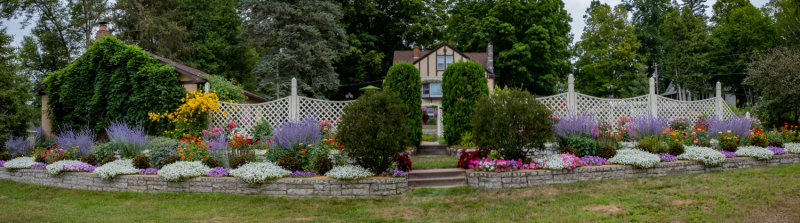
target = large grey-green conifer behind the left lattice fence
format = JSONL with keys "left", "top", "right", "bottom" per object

{"left": 239, "top": 0, "right": 347, "bottom": 98}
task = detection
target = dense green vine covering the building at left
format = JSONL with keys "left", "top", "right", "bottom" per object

{"left": 44, "top": 37, "right": 185, "bottom": 134}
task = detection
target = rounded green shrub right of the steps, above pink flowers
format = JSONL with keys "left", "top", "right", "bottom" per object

{"left": 472, "top": 87, "right": 554, "bottom": 160}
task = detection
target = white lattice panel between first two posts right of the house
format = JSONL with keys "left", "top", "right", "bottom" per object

{"left": 576, "top": 94, "right": 648, "bottom": 123}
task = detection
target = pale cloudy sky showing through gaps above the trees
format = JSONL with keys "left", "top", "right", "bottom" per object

{"left": 0, "top": 0, "right": 769, "bottom": 46}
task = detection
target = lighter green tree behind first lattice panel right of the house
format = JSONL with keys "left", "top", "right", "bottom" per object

{"left": 575, "top": 1, "right": 646, "bottom": 97}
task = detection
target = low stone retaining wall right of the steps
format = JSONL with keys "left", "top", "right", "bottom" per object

{"left": 467, "top": 154, "right": 800, "bottom": 188}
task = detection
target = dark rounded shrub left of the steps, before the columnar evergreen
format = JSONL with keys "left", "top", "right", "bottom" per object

{"left": 337, "top": 91, "right": 409, "bottom": 175}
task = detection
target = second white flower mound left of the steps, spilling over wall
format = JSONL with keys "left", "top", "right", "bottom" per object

{"left": 229, "top": 162, "right": 292, "bottom": 184}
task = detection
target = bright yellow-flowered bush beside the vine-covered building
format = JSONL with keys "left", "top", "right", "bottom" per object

{"left": 147, "top": 91, "right": 220, "bottom": 138}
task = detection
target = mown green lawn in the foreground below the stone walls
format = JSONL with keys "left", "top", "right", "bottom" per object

{"left": 0, "top": 164, "right": 800, "bottom": 222}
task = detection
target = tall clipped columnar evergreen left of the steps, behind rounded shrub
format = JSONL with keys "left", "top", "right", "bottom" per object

{"left": 383, "top": 63, "right": 422, "bottom": 146}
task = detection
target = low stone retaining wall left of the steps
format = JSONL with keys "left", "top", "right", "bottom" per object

{"left": 0, "top": 168, "right": 409, "bottom": 197}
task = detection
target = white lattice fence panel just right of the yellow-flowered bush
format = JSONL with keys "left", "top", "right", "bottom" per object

{"left": 211, "top": 97, "right": 290, "bottom": 135}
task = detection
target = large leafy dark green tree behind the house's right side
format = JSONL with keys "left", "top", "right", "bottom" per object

{"left": 446, "top": 0, "right": 572, "bottom": 95}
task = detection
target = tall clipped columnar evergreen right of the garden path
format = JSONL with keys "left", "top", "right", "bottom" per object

{"left": 440, "top": 61, "right": 490, "bottom": 145}
